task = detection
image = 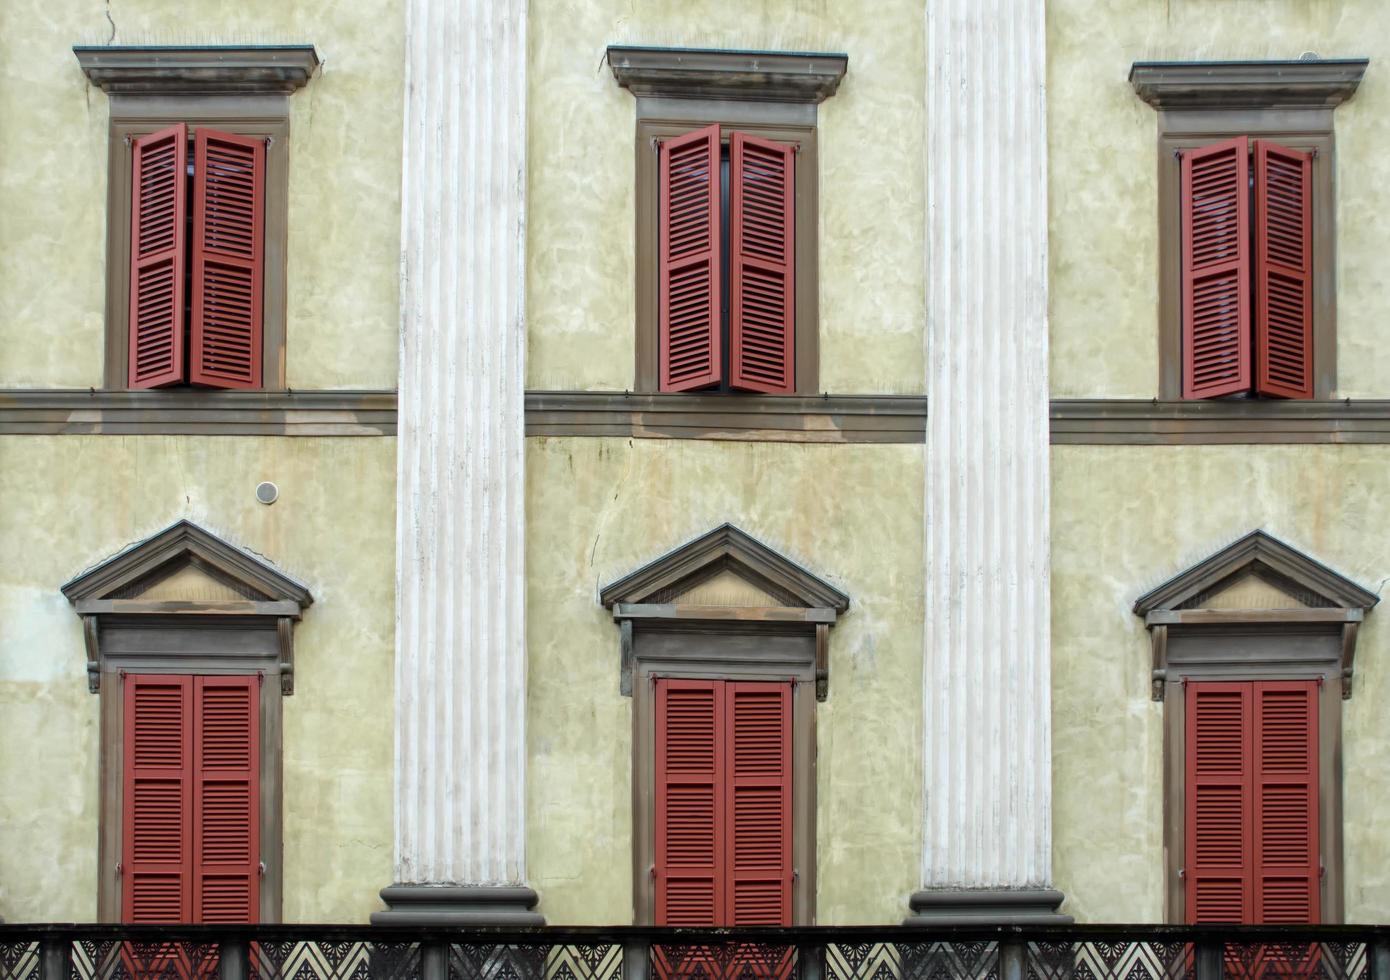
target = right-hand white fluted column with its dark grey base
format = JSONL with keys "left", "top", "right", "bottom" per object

{"left": 912, "top": 0, "right": 1061, "bottom": 922}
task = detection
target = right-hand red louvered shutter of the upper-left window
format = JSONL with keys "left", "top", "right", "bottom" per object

{"left": 190, "top": 129, "right": 265, "bottom": 388}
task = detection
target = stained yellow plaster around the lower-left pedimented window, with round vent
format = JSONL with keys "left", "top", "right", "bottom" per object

{"left": 0, "top": 436, "right": 395, "bottom": 922}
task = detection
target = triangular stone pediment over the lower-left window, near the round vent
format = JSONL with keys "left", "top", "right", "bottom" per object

{"left": 63, "top": 520, "right": 313, "bottom": 609}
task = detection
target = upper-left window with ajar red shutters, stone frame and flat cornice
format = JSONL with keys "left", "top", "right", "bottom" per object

{"left": 74, "top": 44, "right": 318, "bottom": 389}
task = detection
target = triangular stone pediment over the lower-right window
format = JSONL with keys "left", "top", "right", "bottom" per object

{"left": 1134, "top": 531, "right": 1379, "bottom": 616}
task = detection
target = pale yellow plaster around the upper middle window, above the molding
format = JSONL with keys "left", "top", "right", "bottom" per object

{"left": 527, "top": 0, "right": 926, "bottom": 393}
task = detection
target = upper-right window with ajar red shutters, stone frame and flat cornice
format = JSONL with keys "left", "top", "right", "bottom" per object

{"left": 1130, "top": 60, "right": 1366, "bottom": 399}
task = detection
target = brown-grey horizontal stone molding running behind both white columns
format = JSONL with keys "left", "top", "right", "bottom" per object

{"left": 8, "top": 388, "right": 1390, "bottom": 446}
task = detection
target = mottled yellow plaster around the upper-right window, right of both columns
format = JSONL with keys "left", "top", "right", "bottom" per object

{"left": 1047, "top": 0, "right": 1390, "bottom": 398}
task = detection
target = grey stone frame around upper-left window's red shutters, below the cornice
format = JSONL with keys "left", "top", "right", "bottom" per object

{"left": 103, "top": 95, "right": 289, "bottom": 391}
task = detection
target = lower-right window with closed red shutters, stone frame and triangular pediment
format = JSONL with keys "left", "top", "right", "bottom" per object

{"left": 1134, "top": 531, "right": 1376, "bottom": 923}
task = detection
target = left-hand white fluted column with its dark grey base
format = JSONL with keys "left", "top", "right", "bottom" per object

{"left": 374, "top": 0, "right": 539, "bottom": 923}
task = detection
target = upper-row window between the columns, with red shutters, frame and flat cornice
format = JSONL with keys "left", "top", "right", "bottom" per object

{"left": 607, "top": 47, "right": 848, "bottom": 395}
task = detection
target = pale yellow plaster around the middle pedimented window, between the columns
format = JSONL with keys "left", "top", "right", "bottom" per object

{"left": 527, "top": 439, "right": 922, "bottom": 924}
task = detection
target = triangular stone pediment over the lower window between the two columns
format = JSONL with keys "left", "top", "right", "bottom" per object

{"left": 599, "top": 524, "right": 849, "bottom": 613}
